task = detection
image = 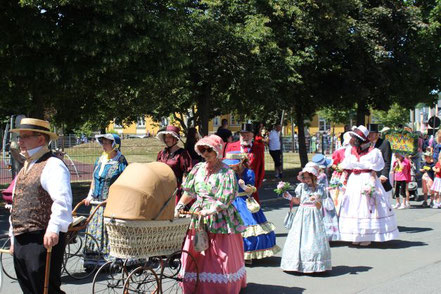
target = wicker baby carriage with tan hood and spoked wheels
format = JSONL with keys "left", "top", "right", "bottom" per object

{"left": 92, "top": 162, "right": 199, "bottom": 293}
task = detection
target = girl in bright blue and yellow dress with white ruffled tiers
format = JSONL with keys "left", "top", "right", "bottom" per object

{"left": 224, "top": 151, "right": 280, "bottom": 264}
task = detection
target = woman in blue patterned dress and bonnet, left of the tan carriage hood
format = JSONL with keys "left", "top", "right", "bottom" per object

{"left": 84, "top": 134, "right": 128, "bottom": 268}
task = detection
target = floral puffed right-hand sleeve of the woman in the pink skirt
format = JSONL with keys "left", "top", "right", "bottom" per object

{"left": 215, "top": 169, "right": 239, "bottom": 212}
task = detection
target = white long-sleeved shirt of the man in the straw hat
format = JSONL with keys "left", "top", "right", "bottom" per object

{"left": 9, "top": 147, "right": 72, "bottom": 240}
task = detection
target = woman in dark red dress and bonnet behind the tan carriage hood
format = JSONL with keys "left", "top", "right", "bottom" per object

{"left": 156, "top": 126, "right": 193, "bottom": 203}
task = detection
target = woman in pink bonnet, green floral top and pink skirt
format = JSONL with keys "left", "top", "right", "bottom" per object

{"left": 175, "top": 135, "right": 246, "bottom": 294}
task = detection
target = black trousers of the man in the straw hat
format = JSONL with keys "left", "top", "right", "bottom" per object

{"left": 14, "top": 231, "right": 66, "bottom": 294}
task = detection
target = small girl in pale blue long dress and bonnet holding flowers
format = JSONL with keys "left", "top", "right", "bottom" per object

{"left": 281, "top": 165, "right": 332, "bottom": 273}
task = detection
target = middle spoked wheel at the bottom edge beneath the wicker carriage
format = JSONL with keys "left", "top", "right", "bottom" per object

{"left": 123, "top": 266, "right": 160, "bottom": 294}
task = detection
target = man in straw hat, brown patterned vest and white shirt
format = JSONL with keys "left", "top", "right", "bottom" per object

{"left": 10, "top": 118, "right": 72, "bottom": 294}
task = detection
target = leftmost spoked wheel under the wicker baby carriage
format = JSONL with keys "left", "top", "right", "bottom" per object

{"left": 92, "top": 259, "right": 127, "bottom": 294}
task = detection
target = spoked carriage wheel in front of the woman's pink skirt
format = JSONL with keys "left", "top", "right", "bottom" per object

{"left": 160, "top": 250, "right": 199, "bottom": 293}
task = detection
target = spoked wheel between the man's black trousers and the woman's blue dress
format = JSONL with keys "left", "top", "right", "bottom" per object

{"left": 63, "top": 232, "right": 102, "bottom": 280}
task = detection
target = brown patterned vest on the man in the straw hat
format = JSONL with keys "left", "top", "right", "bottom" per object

{"left": 11, "top": 152, "right": 53, "bottom": 236}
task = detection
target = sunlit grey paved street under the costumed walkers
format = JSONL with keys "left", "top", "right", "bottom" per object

{"left": 0, "top": 185, "right": 441, "bottom": 294}
